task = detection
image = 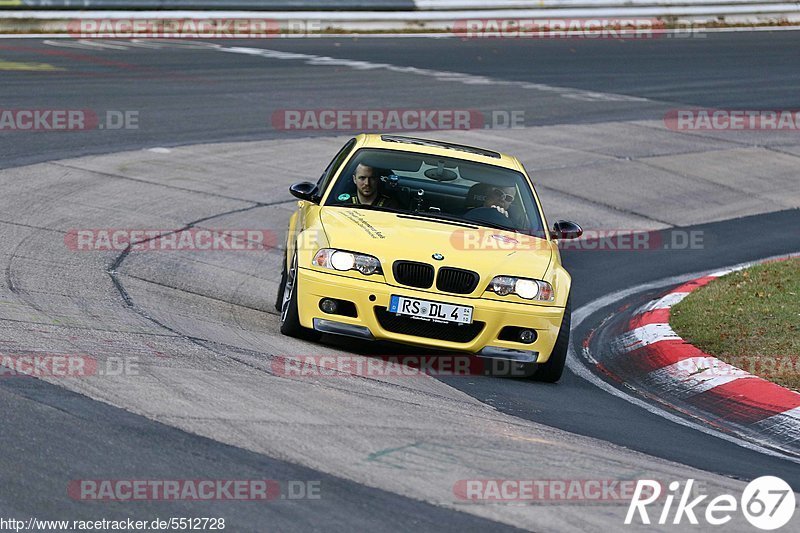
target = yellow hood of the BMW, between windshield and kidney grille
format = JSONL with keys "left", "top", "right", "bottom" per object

{"left": 320, "top": 207, "right": 553, "bottom": 282}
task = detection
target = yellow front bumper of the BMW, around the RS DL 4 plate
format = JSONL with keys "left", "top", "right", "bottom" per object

{"left": 297, "top": 268, "right": 564, "bottom": 363}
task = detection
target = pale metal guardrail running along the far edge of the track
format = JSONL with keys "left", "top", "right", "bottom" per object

{"left": 0, "top": 0, "right": 800, "bottom": 37}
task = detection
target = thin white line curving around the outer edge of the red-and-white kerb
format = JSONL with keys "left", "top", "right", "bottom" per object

{"left": 567, "top": 254, "right": 800, "bottom": 464}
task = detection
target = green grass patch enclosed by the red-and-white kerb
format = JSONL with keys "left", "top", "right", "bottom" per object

{"left": 670, "top": 259, "right": 800, "bottom": 390}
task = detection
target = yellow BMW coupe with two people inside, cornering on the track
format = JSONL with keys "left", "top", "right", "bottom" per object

{"left": 276, "top": 134, "right": 582, "bottom": 382}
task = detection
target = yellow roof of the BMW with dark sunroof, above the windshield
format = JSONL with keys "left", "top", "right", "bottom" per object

{"left": 356, "top": 133, "right": 522, "bottom": 171}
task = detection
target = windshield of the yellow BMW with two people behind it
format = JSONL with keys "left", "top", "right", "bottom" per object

{"left": 325, "top": 149, "right": 543, "bottom": 235}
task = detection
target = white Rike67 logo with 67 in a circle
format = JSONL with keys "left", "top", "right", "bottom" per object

{"left": 625, "top": 476, "right": 795, "bottom": 531}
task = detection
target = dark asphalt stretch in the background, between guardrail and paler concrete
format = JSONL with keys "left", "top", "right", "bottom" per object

{"left": 0, "top": 32, "right": 800, "bottom": 167}
